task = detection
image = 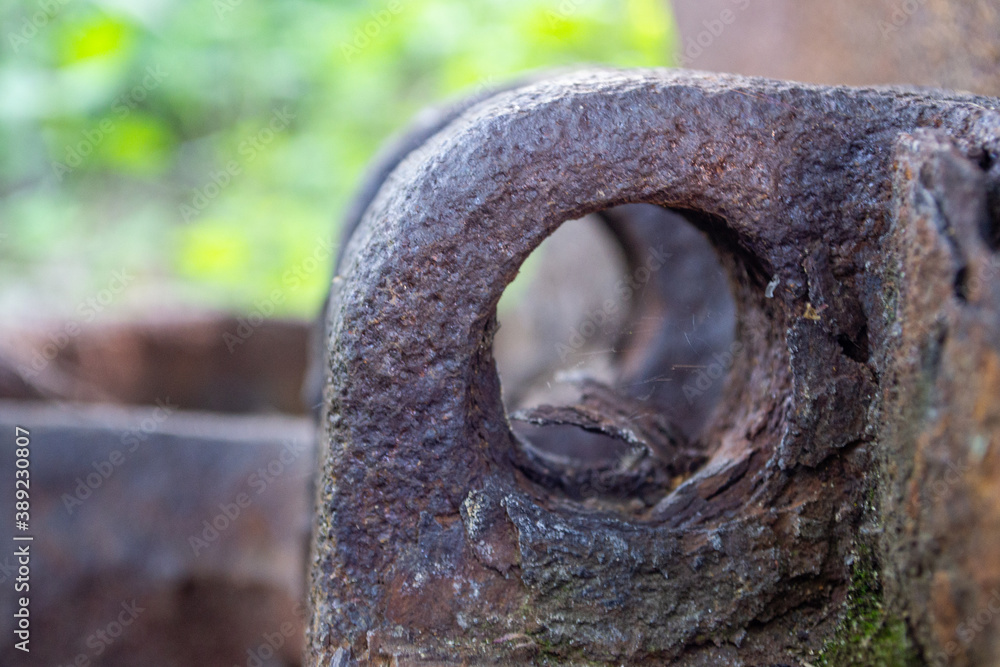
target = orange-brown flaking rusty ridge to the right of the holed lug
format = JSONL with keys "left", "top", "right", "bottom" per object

{"left": 877, "top": 125, "right": 1000, "bottom": 665}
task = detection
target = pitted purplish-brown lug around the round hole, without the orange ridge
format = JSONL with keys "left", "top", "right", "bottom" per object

{"left": 307, "top": 70, "right": 1000, "bottom": 665}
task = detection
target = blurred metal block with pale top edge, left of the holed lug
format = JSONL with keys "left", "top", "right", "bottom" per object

{"left": 0, "top": 400, "right": 314, "bottom": 667}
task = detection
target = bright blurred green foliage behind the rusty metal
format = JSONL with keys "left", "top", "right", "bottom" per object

{"left": 0, "top": 0, "right": 672, "bottom": 315}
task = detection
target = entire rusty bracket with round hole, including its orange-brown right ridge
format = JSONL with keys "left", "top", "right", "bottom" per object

{"left": 307, "top": 70, "right": 1000, "bottom": 666}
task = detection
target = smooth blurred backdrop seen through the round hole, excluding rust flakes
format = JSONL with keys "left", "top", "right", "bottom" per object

{"left": 494, "top": 204, "right": 736, "bottom": 468}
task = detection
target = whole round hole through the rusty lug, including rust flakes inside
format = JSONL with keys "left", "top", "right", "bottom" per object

{"left": 494, "top": 204, "right": 739, "bottom": 516}
